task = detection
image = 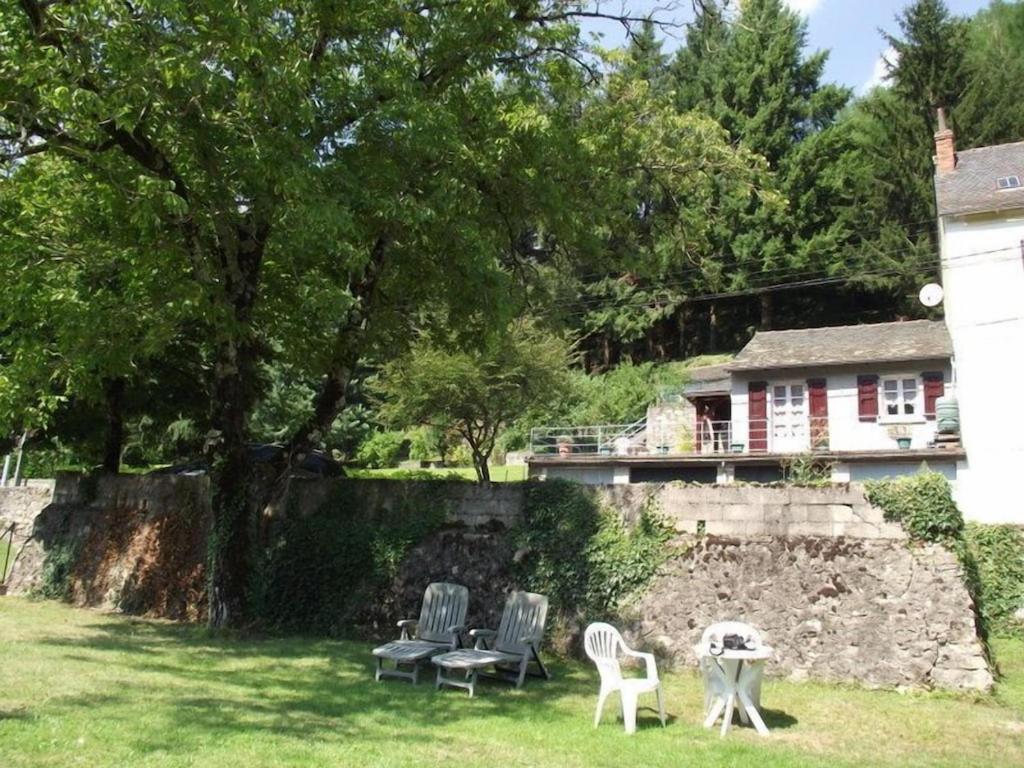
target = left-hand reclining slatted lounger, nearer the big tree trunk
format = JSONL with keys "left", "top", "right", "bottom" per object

{"left": 374, "top": 582, "right": 469, "bottom": 685}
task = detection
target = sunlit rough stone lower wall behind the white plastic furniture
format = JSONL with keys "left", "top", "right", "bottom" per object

{"left": 631, "top": 537, "right": 993, "bottom": 690}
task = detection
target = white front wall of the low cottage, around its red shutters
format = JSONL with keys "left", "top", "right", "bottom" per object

{"left": 732, "top": 360, "right": 952, "bottom": 452}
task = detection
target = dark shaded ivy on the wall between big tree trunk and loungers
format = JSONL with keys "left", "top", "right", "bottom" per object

{"left": 251, "top": 483, "right": 445, "bottom": 634}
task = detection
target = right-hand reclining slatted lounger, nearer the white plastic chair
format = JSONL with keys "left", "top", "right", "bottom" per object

{"left": 432, "top": 592, "right": 551, "bottom": 696}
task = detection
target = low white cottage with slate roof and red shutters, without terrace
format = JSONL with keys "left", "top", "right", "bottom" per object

{"left": 729, "top": 321, "right": 952, "bottom": 479}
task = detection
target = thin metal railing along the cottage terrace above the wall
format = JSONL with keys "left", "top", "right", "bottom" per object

{"left": 530, "top": 417, "right": 828, "bottom": 457}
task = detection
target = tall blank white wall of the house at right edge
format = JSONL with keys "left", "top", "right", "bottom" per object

{"left": 939, "top": 210, "right": 1024, "bottom": 523}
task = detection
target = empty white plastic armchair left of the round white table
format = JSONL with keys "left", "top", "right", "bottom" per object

{"left": 584, "top": 622, "right": 665, "bottom": 733}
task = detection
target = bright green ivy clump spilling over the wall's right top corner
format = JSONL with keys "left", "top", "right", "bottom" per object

{"left": 865, "top": 472, "right": 964, "bottom": 545}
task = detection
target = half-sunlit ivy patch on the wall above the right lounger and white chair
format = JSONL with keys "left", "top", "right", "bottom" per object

{"left": 513, "top": 480, "right": 672, "bottom": 616}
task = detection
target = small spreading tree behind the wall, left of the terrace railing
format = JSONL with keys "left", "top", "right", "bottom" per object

{"left": 378, "top": 321, "right": 572, "bottom": 482}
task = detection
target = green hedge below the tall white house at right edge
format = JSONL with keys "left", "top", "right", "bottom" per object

{"left": 965, "top": 522, "right": 1024, "bottom": 635}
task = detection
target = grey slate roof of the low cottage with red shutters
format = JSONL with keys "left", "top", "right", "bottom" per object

{"left": 728, "top": 321, "right": 952, "bottom": 372}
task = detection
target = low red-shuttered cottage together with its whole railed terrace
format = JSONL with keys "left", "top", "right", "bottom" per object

{"left": 529, "top": 321, "right": 964, "bottom": 483}
